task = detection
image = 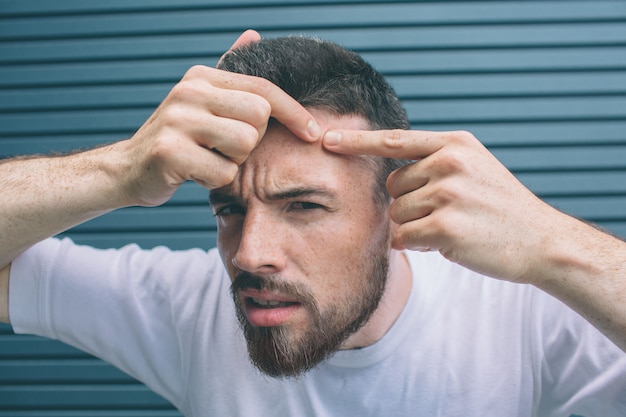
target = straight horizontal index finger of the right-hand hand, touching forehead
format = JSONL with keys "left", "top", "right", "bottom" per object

{"left": 323, "top": 129, "right": 449, "bottom": 159}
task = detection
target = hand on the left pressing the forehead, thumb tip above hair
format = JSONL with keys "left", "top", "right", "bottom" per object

{"left": 121, "top": 31, "right": 322, "bottom": 205}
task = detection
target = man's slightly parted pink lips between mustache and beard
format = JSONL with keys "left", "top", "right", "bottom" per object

{"left": 239, "top": 289, "right": 302, "bottom": 327}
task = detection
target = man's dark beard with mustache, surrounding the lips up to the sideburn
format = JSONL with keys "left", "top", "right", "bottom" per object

{"left": 231, "top": 251, "right": 389, "bottom": 377}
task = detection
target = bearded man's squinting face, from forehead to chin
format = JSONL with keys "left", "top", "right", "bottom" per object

{"left": 211, "top": 112, "right": 390, "bottom": 376}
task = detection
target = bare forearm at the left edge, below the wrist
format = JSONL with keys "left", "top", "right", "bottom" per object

{"left": 0, "top": 143, "right": 131, "bottom": 268}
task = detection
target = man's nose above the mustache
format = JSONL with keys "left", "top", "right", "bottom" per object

{"left": 232, "top": 210, "right": 286, "bottom": 274}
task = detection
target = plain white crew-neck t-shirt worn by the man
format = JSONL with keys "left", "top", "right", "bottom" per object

{"left": 10, "top": 239, "right": 626, "bottom": 417}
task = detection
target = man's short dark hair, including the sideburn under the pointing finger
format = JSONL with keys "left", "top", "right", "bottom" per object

{"left": 218, "top": 36, "right": 410, "bottom": 202}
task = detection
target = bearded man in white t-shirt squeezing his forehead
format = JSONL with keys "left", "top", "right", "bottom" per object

{"left": 0, "top": 33, "right": 626, "bottom": 416}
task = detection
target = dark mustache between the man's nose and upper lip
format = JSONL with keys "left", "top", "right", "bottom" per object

{"left": 230, "top": 272, "right": 317, "bottom": 306}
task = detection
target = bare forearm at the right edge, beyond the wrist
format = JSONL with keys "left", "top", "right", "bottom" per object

{"left": 531, "top": 211, "right": 626, "bottom": 351}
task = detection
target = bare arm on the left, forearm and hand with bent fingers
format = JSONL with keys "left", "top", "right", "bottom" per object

{"left": 0, "top": 31, "right": 322, "bottom": 320}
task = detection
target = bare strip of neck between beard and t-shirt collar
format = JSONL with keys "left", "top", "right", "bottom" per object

{"left": 341, "top": 250, "right": 413, "bottom": 350}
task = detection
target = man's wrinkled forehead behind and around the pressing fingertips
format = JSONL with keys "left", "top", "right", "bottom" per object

{"left": 216, "top": 110, "right": 374, "bottom": 198}
